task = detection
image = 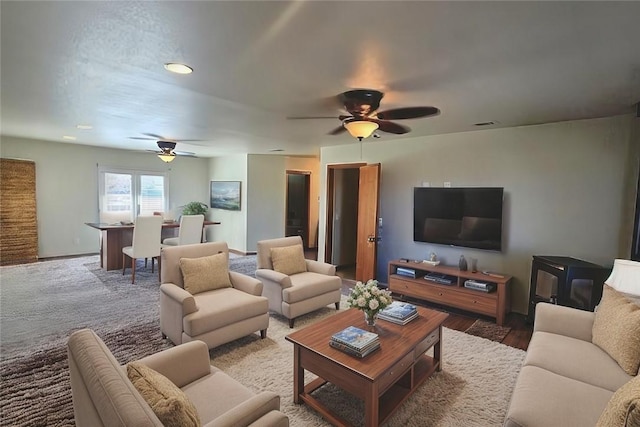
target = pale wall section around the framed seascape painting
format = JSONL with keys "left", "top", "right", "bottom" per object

{"left": 207, "top": 154, "right": 248, "bottom": 252}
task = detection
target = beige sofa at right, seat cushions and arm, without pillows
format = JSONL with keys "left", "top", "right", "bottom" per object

{"left": 504, "top": 303, "right": 632, "bottom": 427}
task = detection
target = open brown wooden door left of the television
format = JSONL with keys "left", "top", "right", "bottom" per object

{"left": 356, "top": 163, "right": 380, "bottom": 282}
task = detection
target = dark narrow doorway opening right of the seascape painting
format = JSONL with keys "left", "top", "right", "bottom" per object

{"left": 285, "top": 171, "right": 311, "bottom": 249}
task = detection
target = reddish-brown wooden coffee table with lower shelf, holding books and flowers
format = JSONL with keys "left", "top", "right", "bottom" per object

{"left": 286, "top": 307, "right": 449, "bottom": 426}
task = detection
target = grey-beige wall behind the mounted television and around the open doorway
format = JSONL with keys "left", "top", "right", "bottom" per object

{"left": 319, "top": 116, "right": 634, "bottom": 313}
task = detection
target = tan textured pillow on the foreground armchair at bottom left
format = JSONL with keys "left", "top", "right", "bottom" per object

{"left": 127, "top": 362, "right": 201, "bottom": 427}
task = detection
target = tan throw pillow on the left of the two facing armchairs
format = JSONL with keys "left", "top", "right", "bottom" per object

{"left": 180, "top": 252, "right": 231, "bottom": 295}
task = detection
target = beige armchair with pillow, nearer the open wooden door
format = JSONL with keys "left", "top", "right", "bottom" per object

{"left": 256, "top": 236, "right": 342, "bottom": 328}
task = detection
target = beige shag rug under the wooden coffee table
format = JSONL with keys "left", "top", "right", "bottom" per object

{"left": 211, "top": 304, "right": 525, "bottom": 427}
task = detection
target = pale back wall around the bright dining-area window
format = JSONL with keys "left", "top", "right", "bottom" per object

{"left": 0, "top": 136, "right": 208, "bottom": 258}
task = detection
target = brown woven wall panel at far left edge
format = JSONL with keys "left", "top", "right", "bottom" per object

{"left": 0, "top": 159, "right": 38, "bottom": 265}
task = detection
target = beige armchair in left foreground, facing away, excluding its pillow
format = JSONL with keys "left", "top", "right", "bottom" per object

{"left": 68, "top": 329, "right": 289, "bottom": 427}
